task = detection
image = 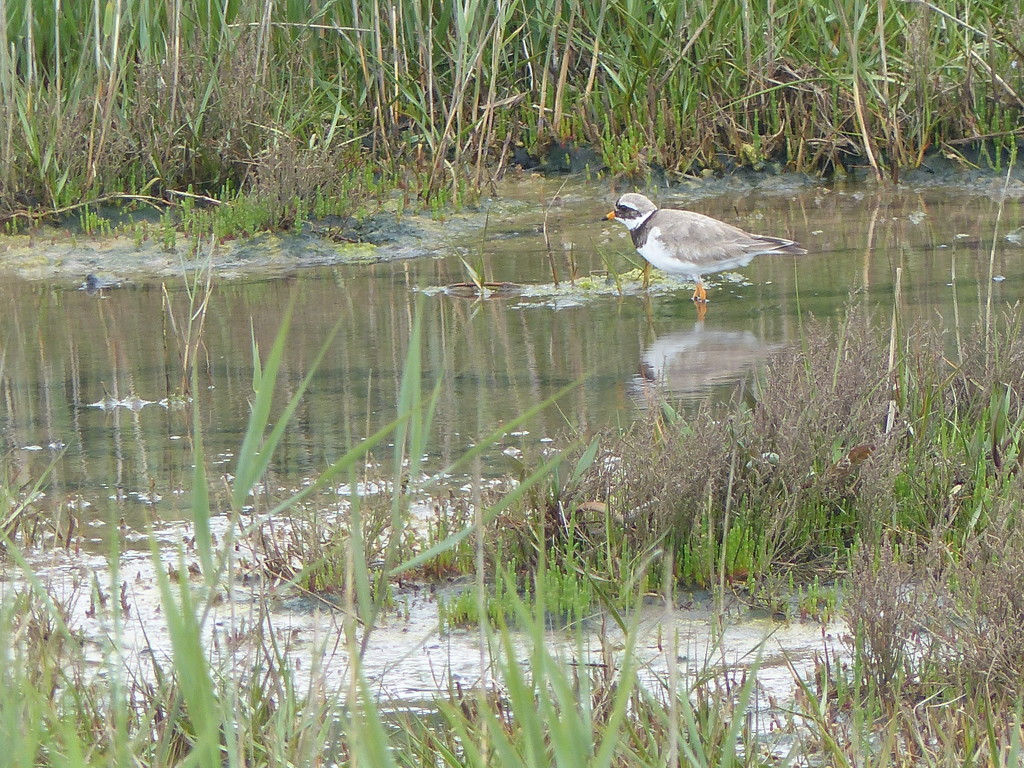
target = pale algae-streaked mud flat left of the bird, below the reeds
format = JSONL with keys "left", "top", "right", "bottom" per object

{"left": 0, "top": 178, "right": 561, "bottom": 289}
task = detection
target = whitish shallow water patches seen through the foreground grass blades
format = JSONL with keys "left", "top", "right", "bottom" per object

{"left": 22, "top": 519, "right": 848, "bottom": 736}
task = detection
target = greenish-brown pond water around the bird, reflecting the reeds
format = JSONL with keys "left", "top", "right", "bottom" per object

{"left": 0, "top": 177, "right": 1024, "bottom": 541}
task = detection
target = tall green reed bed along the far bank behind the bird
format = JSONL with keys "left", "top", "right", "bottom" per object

{"left": 0, "top": 0, "right": 1024, "bottom": 232}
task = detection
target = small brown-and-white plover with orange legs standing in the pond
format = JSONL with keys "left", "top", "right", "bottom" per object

{"left": 604, "top": 193, "right": 807, "bottom": 304}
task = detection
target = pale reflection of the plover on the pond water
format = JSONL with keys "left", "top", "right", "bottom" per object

{"left": 636, "top": 323, "right": 771, "bottom": 398}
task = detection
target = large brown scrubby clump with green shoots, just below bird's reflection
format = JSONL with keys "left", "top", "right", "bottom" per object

{"left": 581, "top": 307, "right": 1024, "bottom": 583}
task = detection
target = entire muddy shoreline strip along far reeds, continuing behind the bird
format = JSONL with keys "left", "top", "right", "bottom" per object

{"left": 8, "top": 164, "right": 1024, "bottom": 287}
